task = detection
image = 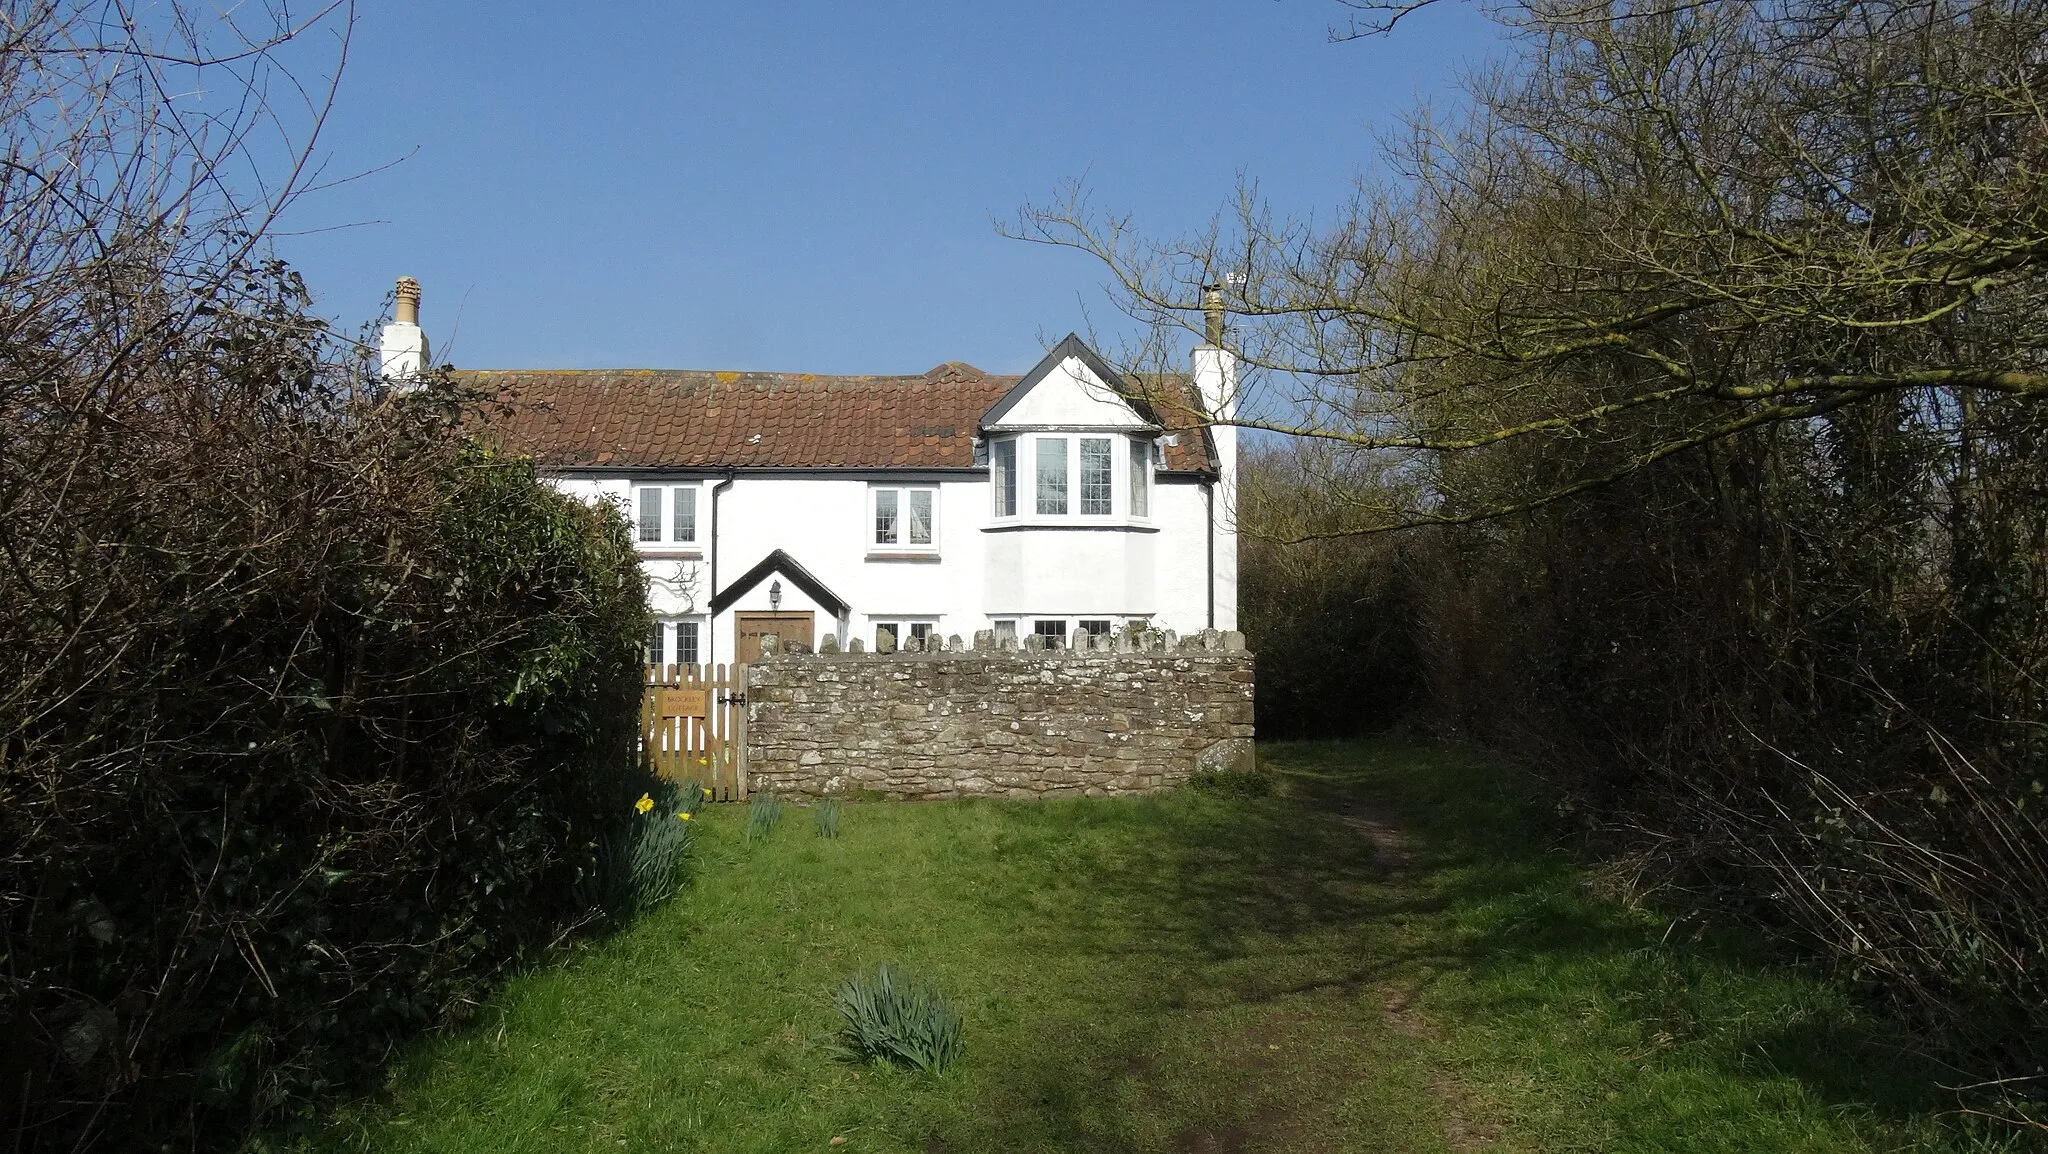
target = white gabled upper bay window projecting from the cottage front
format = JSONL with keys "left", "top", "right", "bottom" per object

{"left": 981, "top": 334, "right": 1163, "bottom": 529}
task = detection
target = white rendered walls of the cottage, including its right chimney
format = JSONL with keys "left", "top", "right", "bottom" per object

{"left": 551, "top": 338, "right": 1237, "bottom": 662}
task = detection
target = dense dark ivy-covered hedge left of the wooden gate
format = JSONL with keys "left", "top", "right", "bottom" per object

{"left": 0, "top": 269, "right": 647, "bottom": 1150}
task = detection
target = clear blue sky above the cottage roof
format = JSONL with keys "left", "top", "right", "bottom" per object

{"left": 276, "top": 0, "right": 1499, "bottom": 373}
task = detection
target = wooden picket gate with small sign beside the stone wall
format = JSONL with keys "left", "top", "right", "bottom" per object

{"left": 641, "top": 664, "right": 748, "bottom": 801}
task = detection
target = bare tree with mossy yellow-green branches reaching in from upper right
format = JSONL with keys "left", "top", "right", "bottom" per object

{"left": 1014, "top": 0, "right": 2048, "bottom": 535}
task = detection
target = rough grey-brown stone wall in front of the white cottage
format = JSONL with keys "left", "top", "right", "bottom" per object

{"left": 745, "top": 629, "right": 1253, "bottom": 797}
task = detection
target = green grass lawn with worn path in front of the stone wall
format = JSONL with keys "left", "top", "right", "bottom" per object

{"left": 299, "top": 744, "right": 1999, "bottom": 1154}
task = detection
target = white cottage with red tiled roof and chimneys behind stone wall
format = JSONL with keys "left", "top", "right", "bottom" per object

{"left": 385, "top": 287, "right": 1237, "bottom": 664}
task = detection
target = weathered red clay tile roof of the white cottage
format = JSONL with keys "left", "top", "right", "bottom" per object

{"left": 457, "top": 361, "right": 1208, "bottom": 469}
